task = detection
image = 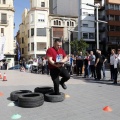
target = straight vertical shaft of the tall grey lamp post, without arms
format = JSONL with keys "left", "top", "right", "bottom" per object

{"left": 96, "top": 7, "right": 99, "bottom": 49}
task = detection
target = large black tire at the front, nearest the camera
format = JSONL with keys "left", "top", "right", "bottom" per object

{"left": 18, "top": 93, "right": 44, "bottom": 108}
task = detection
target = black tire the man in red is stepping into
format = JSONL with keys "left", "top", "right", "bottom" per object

{"left": 45, "top": 92, "right": 65, "bottom": 102}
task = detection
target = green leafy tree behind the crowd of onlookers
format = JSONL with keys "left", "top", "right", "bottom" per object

{"left": 70, "top": 39, "right": 89, "bottom": 54}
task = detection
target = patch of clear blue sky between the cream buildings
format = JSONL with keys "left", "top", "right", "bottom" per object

{"left": 14, "top": 0, "right": 30, "bottom": 36}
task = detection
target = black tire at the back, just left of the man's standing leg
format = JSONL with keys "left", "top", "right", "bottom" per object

{"left": 34, "top": 86, "right": 54, "bottom": 94}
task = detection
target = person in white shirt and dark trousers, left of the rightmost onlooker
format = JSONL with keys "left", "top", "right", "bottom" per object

{"left": 110, "top": 49, "right": 116, "bottom": 80}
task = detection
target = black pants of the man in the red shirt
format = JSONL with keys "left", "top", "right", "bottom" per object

{"left": 50, "top": 67, "right": 70, "bottom": 94}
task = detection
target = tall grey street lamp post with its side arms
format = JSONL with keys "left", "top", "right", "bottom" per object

{"left": 86, "top": 3, "right": 107, "bottom": 49}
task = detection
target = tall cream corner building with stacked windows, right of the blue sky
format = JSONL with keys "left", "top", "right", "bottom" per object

{"left": 20, "top": 0, "right": 50, "bottom": 58}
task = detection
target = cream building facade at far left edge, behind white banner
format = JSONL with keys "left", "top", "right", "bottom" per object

{"left": 0, "top": 0, "right": 15, "bottom": 68}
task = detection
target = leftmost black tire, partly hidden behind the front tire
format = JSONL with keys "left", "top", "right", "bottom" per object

{"left": 10, "top": 90, "right": 32, "bottom": 101}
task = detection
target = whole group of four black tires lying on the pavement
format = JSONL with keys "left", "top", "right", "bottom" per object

{"left": 10, "top": 87, "right": 65, "bottom": 108}
